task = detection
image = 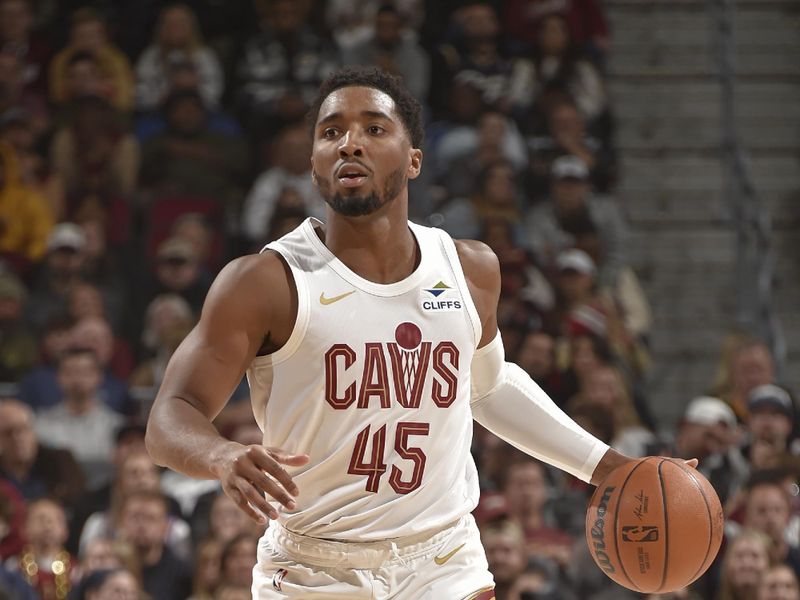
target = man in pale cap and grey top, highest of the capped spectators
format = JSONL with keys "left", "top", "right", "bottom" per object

{"left": 525, "top": 156, "right": 627, "bottom": 284}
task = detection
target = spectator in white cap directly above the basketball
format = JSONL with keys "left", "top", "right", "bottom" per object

{"left": 675, "top": 396, "right": 749, "bottom": 504}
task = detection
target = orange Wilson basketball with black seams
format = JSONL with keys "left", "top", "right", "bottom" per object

{"left": 586, "top": 456, "right": 724, "bottom": 593}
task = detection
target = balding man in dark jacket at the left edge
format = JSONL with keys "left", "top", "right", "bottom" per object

{"left": 0, "top": 399, "right": 86, "bottom": 510}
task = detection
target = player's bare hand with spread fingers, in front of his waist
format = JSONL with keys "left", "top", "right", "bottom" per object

{"left": 215, "top": 442, "right": 309, "bottom": 524}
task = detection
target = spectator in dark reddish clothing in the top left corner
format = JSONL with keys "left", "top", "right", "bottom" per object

{"left": 0, "top": 0, "right": 50, "bottom": 94}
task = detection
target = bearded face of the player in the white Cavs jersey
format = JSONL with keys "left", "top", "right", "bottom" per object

{"left": 311, "top": 87, "right": 422, "bottom": 217}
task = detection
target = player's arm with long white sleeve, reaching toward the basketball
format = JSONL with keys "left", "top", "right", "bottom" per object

{"left": 456, "top": 240, "right": 633, "bottom": 485}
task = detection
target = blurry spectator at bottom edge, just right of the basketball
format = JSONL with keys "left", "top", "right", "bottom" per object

{"left": 717, "top": 531, "right": 770, "bottom": 600}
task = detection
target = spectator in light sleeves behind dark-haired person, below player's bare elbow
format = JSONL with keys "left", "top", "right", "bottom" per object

{"left": 80, "top": 451, "right": 191, "bottom": 560}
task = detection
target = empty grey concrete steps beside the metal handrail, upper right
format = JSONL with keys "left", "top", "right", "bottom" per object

{"left": 604, "top": 0, "right": 800, "bottom": 426}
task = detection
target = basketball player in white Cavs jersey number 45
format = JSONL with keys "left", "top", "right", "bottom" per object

{"left": 147, "top": 69, "right": 630, "bottom": 600}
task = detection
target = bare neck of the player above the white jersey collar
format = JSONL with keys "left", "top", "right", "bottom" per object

{"left": 319, "top": 198, "right": 419, "bottom": 284}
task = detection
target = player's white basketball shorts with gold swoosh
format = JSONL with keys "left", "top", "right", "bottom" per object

{"left": 253, "top": 514, "right": 494, "bottom": 600}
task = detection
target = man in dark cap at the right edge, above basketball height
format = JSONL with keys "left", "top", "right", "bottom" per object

{"left": 743, "top": 383, "right": 800, "bottom": 467}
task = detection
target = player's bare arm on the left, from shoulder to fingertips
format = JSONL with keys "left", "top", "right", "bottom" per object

{"left": 145, "top": 253, "right": 308, "bottom": 521}
